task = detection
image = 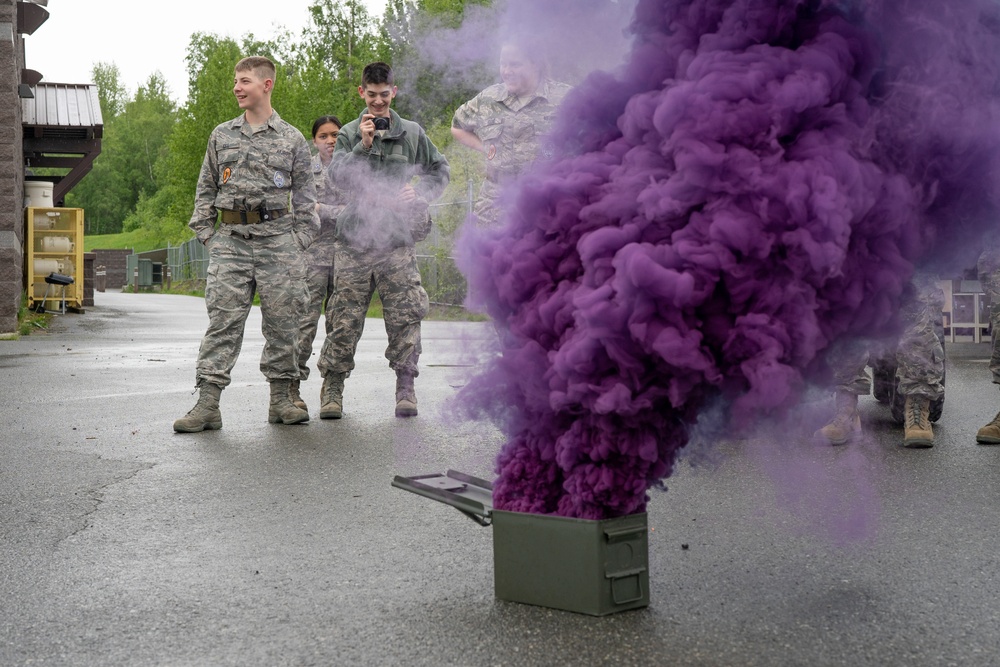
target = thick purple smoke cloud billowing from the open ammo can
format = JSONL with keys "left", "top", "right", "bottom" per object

{"left": 461, "top": 0, "right": 1000, "bottom": 519}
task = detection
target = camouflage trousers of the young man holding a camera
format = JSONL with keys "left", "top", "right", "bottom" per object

{"left": 317, "top": 245, "right": 430, "bottom": 377}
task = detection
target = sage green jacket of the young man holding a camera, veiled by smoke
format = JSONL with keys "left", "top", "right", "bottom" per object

{"left": 327, "top": 109, "right": 451, "bottom": 249}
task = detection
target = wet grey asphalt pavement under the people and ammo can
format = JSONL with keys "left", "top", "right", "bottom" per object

{"left": 0, "top": 292, "right": 1000, "bottom": 667}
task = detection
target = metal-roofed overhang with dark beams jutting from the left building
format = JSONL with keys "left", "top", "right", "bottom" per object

{"left": 21, "top": 82, "right": 104, "bottom": 205}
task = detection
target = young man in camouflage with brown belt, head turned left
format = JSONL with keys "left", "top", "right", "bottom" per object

{"left": 174, "top": 56, "right": 319, "bottom": 433}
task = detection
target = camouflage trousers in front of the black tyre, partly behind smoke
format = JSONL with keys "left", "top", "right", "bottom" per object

{"left": 829, "top": 274, "right": 944, "bottom": 401}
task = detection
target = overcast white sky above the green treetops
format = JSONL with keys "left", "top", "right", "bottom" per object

{"left": 24, "top": 0, "right": 385, "bottom": 103}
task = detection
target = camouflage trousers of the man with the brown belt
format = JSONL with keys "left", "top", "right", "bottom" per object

{"left": 196, "top": 233, "right": 307, "bottom": 387}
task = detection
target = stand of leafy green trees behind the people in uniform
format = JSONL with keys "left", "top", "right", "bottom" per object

{"left": 77, "top": 0, "right": 482, "bottom": 266}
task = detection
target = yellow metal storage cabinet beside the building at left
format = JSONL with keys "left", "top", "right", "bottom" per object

{"left": 24, "top": 206, "right": 83, "bottom": 311}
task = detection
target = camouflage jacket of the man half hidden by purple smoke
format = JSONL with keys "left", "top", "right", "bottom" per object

{"left": 451, "top": 79, "right": 570, "bottom": 185}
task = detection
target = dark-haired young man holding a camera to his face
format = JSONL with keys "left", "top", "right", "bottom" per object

{"left": 317, "top": 62, "right": 450, "bottom": 419}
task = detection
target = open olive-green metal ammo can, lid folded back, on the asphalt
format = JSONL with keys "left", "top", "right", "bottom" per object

{"left": 392, "top": 470, "right": 649, "bottom": 616}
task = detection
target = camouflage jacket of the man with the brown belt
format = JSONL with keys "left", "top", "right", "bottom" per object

{"left": 188, "top": 112, "right": 319, "bottom": 247}
